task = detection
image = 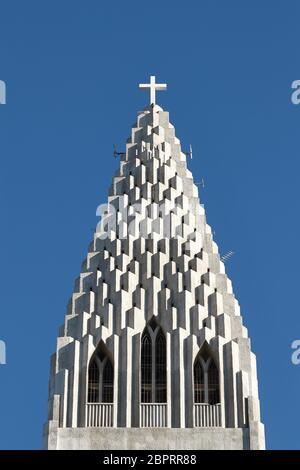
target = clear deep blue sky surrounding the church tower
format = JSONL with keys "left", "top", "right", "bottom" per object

{"left": 0, "top": 0, "right": 300, "bottom": 449}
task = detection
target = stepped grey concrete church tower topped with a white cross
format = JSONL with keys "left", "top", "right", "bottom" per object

{"left": 44, "top": 77, "right": 265, "bottom": 450}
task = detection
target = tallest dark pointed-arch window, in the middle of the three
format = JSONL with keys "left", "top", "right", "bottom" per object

{"left": 141, "top": 319, "right": 167, "bottom": 403}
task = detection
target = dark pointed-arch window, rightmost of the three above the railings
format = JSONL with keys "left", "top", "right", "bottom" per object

{"left": 194, "top": 344, "right": 220, "bottom": 405}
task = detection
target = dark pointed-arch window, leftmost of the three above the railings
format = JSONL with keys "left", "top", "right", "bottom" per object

{"left": 87, "top": 344, "right": 114, "bottom": 403}
